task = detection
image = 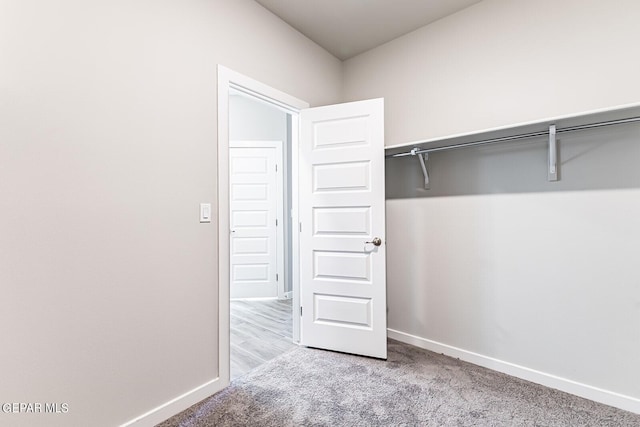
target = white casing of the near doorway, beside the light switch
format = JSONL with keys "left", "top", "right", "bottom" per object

{"left": 217, "top": 65, "right": 309, "bottom": 388}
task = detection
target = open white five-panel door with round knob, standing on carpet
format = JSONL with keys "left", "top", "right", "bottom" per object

{"left": 298, "top": 99, "right": 387, "bottom": 358}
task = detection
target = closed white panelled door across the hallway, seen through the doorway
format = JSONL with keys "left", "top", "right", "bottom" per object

{"left": 229, "top": 141, "right": 284, "bottom": 298}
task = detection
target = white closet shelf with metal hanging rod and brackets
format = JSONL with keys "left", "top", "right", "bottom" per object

{"left": 385, "top": 104, "right": 640, "bottom": 189}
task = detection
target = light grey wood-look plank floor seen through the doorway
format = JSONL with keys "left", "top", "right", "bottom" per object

{"left": 231, "top": 299, "right": 295, "bottom": 380}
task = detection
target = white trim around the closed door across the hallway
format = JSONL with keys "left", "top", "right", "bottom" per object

{"left": 229, "top": 140, "right": 287, "bottom": 299}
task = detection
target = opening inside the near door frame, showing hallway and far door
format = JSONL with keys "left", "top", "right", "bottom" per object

{"left": 229, "top": 88, "right": 295, "bottom": 380}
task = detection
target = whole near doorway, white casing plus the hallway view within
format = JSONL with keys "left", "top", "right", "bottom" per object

{"left": 218, "top": 66, "right": 309, "bottom": 387}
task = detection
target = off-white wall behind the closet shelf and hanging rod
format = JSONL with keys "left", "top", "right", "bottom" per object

{"left": 344, "top": 0, "right": 640, "bottom": 412}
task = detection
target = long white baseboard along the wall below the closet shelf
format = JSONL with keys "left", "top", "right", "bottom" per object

{"left": 387, "top": 329, "right": 640, "bottom": 414}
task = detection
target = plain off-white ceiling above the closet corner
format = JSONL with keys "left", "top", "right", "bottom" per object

{"left": 256, "top": 0, "right": 481, "bottom": 60}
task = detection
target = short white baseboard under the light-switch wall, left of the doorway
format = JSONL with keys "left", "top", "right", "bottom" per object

{"left": 120, "top": 378, "right": 223, "bottom": 427}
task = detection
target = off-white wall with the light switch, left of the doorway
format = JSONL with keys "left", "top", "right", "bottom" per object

{"left": 0, "top": 0, "right": 342, "bottom": 426}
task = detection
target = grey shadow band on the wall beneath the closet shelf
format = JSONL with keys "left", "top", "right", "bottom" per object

{"left": 386, "top": 124, "right": 640, "bottom": 199}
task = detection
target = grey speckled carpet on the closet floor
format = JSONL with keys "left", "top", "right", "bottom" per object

{"left": 160, "top": 340, "right": 640, "bottom": 427}
